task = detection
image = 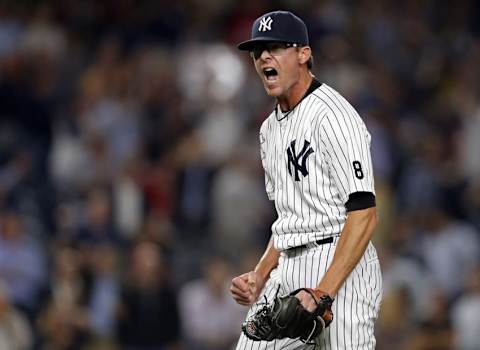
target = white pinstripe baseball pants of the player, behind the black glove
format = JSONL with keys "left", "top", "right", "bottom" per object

{"left": 236, "top": 238, "right": 382, "bottom": 350}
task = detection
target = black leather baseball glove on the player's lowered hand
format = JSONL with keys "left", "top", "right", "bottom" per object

{"left": 242, "top": 288, "right": 333, "bottom": 344}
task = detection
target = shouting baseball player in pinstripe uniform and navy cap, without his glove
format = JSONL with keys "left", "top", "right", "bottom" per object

{"left": 230, "top": 11, "right": 382, "bottom": 350}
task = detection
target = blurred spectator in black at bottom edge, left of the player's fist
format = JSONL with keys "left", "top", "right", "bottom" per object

{"left": 117, "top": 242, "right": 180, "bottom": 350}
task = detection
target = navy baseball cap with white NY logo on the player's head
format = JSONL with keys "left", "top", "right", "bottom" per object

{"left": 238, "top": 11, "right": 308, "bottom": 51}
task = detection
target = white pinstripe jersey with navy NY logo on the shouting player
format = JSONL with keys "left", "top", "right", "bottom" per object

{"left": 260, "top": 84, "right": 375, "bottom": 250}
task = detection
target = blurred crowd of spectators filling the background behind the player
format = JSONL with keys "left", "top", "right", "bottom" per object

{"left": 0, "top": 0, "right": 480, "bottom": 350}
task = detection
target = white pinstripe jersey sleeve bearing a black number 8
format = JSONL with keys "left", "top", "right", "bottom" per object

{"left": 319, "top": 94, "right": 375, "bottom": 203}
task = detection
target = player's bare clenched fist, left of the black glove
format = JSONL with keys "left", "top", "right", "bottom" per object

{"left": 230, "top": 271, "right": 264, "bottom": 305}
